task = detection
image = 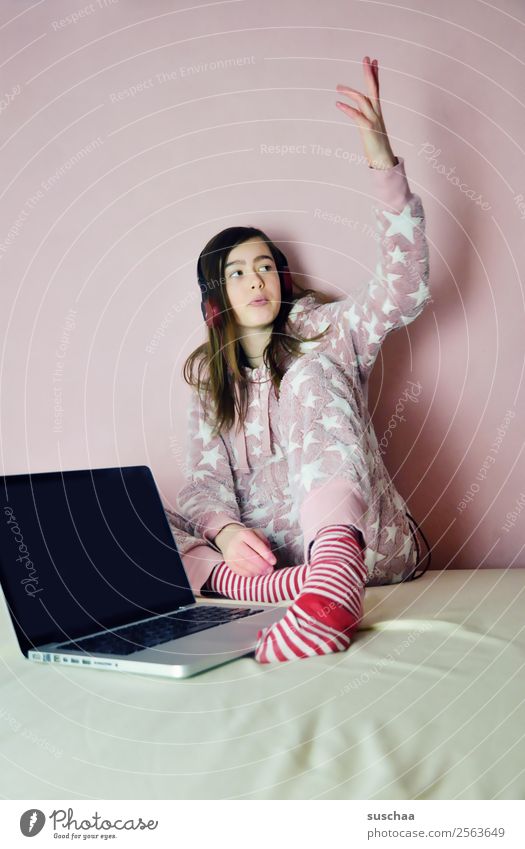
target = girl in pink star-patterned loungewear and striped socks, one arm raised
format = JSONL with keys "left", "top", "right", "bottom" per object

{"left": 168, "top": 57, "right": 430, "bottom": 663}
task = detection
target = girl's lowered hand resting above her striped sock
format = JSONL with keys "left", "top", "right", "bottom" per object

{"left": 215, "top": 524, "right": 277, "bottom": 578}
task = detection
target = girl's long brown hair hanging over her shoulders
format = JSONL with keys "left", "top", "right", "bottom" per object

{"left": 183, "top": 227, "right": 332, "bottom": 437}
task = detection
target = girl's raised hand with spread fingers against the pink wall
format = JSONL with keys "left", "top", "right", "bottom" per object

{"left": 336, "top": 56, "right": 397, "bottom": 168}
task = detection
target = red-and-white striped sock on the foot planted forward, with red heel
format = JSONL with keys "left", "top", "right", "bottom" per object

{"left": 255, "top": 524, "right": 367, "bottom": 663}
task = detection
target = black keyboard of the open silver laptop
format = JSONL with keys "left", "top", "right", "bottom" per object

{"left": 54, "top": 604, "right": 264, "bottom": 654}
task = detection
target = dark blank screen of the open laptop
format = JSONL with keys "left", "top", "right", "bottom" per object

{"left": 0, "top": 466, "right": 195, "bottom": 653}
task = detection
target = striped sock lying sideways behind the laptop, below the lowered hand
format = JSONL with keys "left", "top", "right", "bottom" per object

{"left": 201, "top": 560, "right": 311, "bottom": 604}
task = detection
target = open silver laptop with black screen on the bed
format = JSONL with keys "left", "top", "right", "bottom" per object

{"left": 0, "top": 466, "right": 286, "bottom": 678}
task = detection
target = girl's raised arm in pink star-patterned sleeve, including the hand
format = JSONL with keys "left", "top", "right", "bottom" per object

{"left": 290, "top": 56, "right": 431, "bottom": 382}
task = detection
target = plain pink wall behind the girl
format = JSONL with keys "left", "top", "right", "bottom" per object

{"left": 0, "top": 0, "right": 525, "bottom": 568}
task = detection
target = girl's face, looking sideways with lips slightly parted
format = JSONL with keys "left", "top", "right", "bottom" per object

{"left": 224, "top": 239, "right": 281, "bottom": 328}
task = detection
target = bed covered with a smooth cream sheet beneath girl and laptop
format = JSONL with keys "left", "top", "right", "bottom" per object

{"left": 0, "top": 569, "right": 525, "bottom": 800}
